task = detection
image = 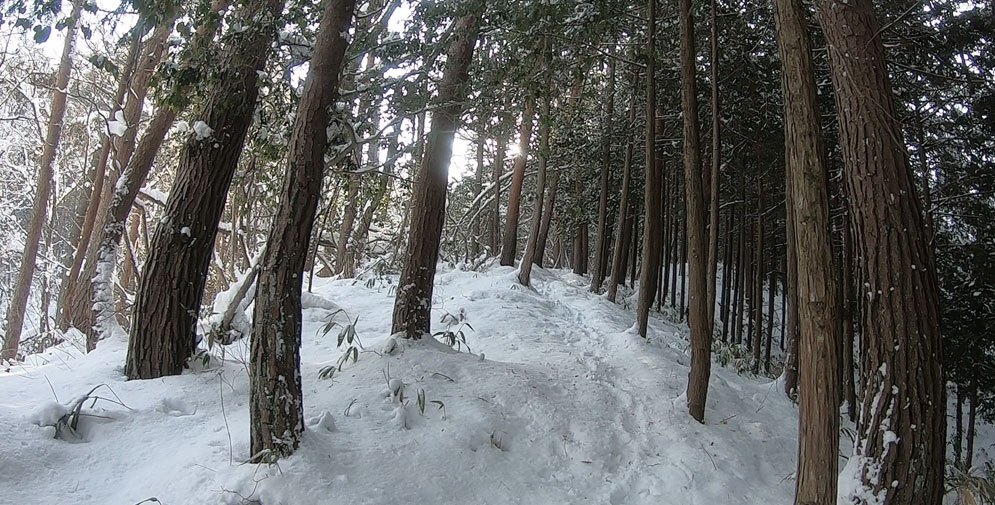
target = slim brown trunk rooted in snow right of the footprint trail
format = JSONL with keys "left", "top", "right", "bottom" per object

{"left": 679, "top": 0, "right": 712, "bottom": 423}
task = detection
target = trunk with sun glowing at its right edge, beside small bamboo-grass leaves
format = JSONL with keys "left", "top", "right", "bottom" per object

{"left": 391, "top": 7, "right": 482, "bottom": 339}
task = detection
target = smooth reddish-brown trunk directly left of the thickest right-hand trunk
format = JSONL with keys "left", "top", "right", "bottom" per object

{"left": 774, "top": 0, "right": 840, "bottom": 505}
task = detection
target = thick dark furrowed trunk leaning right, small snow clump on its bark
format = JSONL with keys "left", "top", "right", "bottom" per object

{"left": 126, "top": 0, "right": 283, "bottom": 379}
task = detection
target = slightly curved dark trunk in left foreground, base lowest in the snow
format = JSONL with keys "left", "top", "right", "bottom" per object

{"left": 249, "top": 0, "right": 356, "bottom": 461}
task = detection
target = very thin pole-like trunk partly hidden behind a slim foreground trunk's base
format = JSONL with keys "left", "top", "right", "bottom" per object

{"left": 708, "top": 0, "right": 722, "bottom": 324}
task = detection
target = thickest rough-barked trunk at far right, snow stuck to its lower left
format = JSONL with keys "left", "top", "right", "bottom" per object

{"left": 812, "top": 0, "right": 947, "bottom": 505}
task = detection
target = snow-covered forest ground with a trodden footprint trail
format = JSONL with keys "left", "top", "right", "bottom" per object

{"left": 0, "top": 267, "right": 980, "bottom": 505}
